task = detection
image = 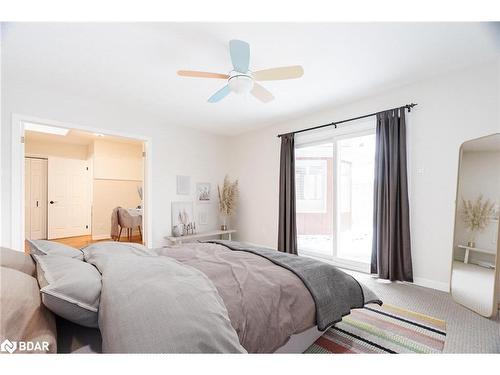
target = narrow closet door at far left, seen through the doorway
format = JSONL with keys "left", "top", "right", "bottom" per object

{"left": 25, "top": 158, "right": 47, "bottom": 240}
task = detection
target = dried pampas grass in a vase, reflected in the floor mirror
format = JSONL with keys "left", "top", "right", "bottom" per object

{"left": 461, "top": 195, "right": 495, "bottom": 247}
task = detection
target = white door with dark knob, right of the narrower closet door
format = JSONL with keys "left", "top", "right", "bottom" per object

{"left": 48, "top": 157, "right": 91, "bottom": 239}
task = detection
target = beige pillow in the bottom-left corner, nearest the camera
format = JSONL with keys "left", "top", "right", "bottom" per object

{"left": 0, "top": 267, "right": 57, "bottom": 354}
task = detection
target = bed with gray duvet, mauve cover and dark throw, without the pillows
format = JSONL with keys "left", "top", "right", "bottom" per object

{"left": 1, "top": 241, "right": 381, "bottom": 353}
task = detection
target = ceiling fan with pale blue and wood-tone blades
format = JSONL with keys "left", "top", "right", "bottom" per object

{"left": 177, "top": 39, "right": 304, "bottom": 103}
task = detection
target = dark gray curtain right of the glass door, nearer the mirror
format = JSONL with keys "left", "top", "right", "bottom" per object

{"left": 371, "top": 108, "right": 413, "bottom": 281}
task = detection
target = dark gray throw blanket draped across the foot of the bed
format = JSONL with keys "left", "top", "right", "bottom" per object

{"left": 205, "top": 240, "right": 382, "bottom": 331}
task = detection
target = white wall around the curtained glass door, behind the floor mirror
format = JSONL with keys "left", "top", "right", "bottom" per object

{"left": 230, "top": 61, "right": 500, "bottom": 290}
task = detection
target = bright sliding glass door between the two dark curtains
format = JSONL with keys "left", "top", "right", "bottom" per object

{"left": 295, "top": 123, "right": 375, "bottom": 268}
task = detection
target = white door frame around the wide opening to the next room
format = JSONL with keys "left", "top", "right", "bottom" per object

{"left": 11, "top": 113, "right": 153, "bottom": 251}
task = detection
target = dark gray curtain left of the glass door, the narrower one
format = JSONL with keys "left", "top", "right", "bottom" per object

{"left": 278, "top": 134, "right": 297, "bottom": 254}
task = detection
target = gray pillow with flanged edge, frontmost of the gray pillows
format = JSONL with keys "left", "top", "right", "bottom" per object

{"left": 33, "top": 254, "right": 101, "bottom": 327}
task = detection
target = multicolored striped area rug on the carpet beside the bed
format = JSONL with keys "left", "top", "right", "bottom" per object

{"left": 305, "top": 304, "right": 446, "bottom": 353}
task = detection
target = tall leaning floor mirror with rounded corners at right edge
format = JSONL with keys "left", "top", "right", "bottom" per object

{"left": 451, "top": 134, "right": 500, "bottom": 317}
